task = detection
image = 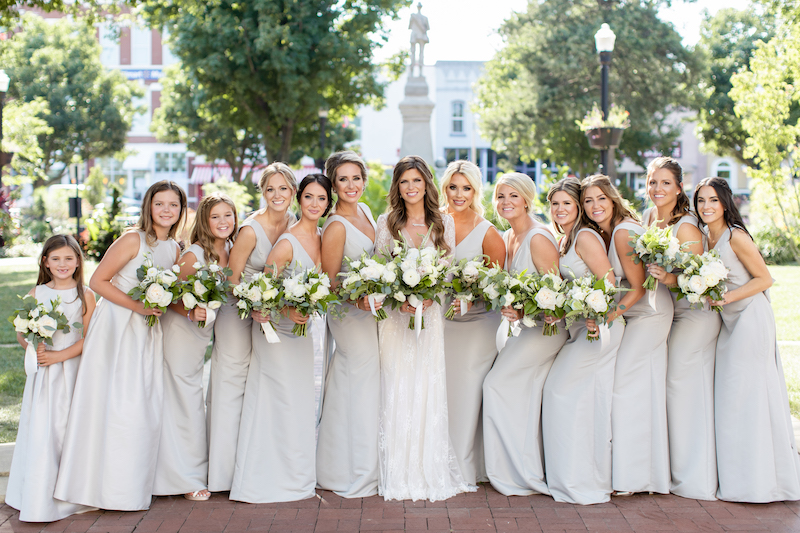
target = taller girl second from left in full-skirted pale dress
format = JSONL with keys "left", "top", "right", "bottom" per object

{"left": 55, "top": 180, "right": 186, "bottom": 511}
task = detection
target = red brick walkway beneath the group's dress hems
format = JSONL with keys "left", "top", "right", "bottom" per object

{"left": 0, "top": 485, "right": 800, "bottom": 533}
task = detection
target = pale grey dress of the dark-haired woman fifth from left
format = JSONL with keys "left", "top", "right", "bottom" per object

{"left": 230, "top": 233, "right": 317, "bottom": 503}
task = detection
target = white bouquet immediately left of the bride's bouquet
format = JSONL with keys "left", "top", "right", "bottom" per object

{"left": 338, "top": 252, "right": 397, "bottom": 322}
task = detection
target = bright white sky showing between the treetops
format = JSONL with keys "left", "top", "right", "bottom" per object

{"left": 376, "top": 0, "right": 748, "bottom": 65}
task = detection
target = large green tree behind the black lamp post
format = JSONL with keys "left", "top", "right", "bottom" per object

{"left": 475, "top": 0, "right": 702, "bottom": 175}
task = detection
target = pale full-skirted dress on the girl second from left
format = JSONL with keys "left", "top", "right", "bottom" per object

{"left": 55, "top": 231, "right": 179, "bottom": 511}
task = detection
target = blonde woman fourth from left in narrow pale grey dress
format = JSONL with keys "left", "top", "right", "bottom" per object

{"left": 206, "top": 163, "right": 297, "bottom": 492}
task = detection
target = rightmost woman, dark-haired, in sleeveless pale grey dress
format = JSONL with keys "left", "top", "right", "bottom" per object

{"left": 694, "top": 178, "right": 800, "bottom": 503}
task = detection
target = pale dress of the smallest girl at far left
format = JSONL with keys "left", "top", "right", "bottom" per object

{"left": 6, "top": 285, "right": 88, "bottom": 522}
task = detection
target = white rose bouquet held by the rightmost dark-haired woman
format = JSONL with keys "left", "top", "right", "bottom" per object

{"left": 670, "top": 250, "right": 729, "bottom": 313}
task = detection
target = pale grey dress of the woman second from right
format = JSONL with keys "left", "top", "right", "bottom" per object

{"left": 643, "top": 211, "right": 722, "bottom": 500}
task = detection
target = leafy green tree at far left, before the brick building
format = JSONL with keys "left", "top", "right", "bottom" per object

{"left": 0, "top": 15, "right": 144, "bottom": 186}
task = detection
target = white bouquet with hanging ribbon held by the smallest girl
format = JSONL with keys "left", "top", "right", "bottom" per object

{"left": 8, "top": 294, "right": 83, "bottom": 375}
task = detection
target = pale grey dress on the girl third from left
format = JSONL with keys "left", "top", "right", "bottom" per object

{"left": 153, "top": 244, "right": 230, "bottom": 495}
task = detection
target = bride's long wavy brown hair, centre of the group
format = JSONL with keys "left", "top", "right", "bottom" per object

{"left": 386, "top": 155, "right": 451, "bottom": 253}
